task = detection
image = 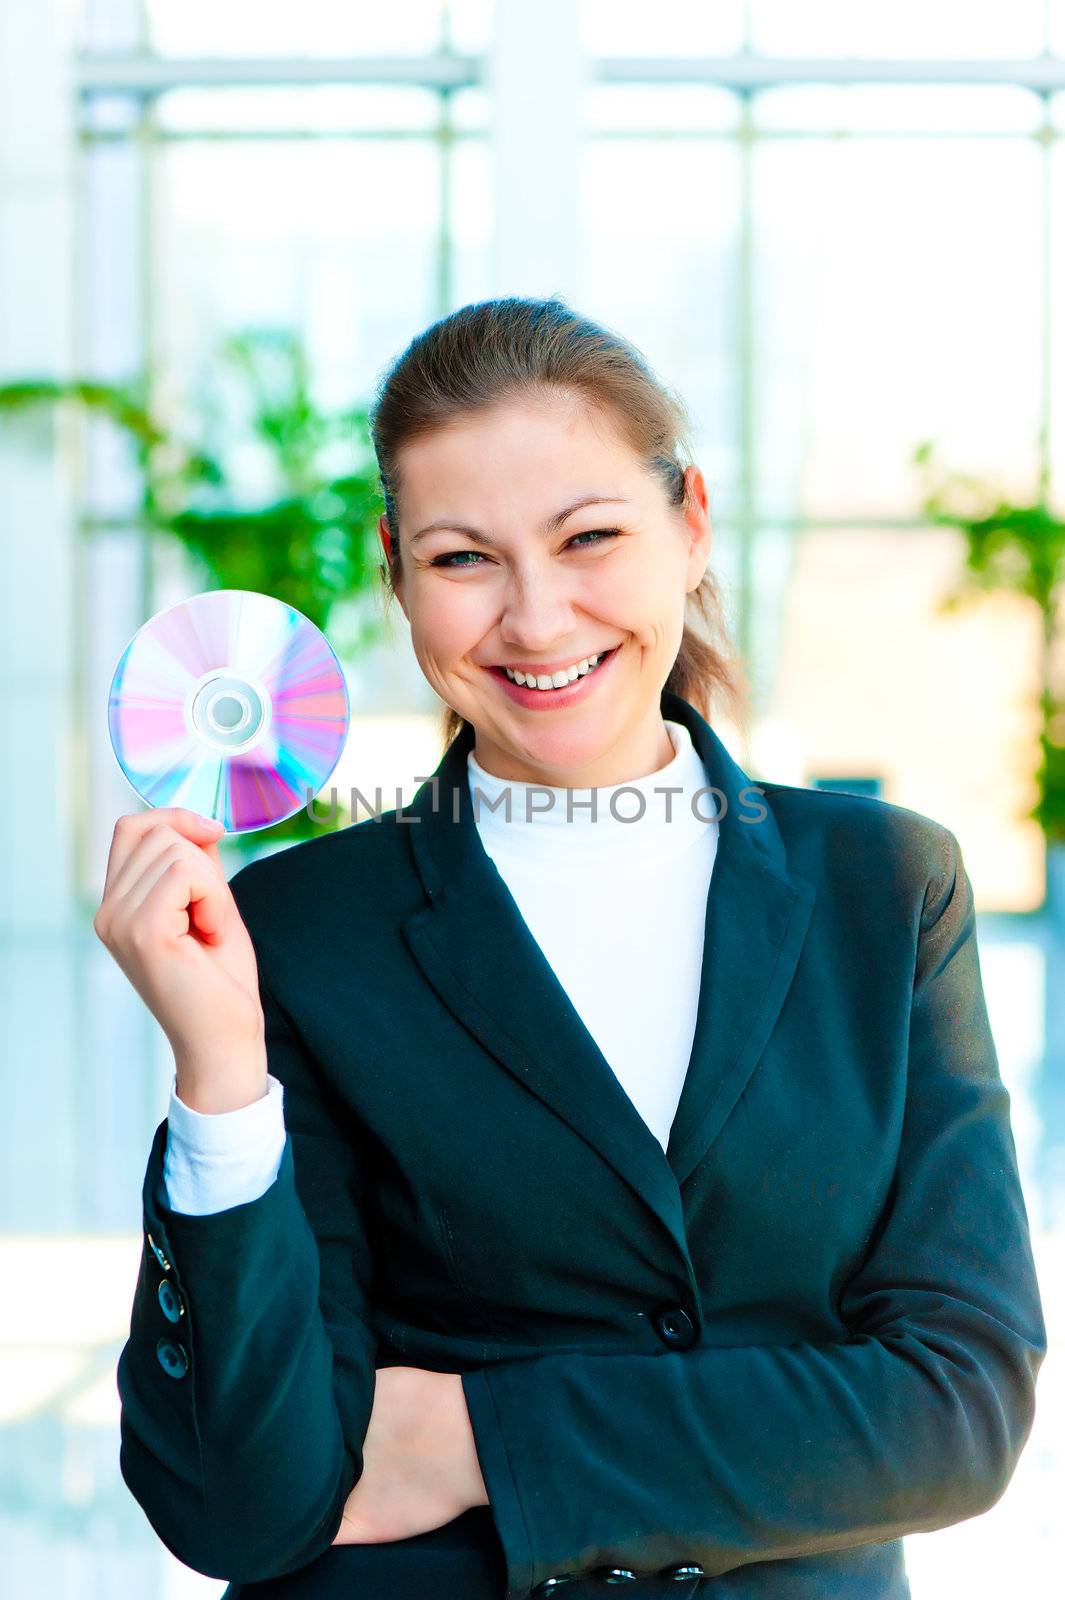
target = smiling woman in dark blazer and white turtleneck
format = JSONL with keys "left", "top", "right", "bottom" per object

{"left": 96, "top": 299, "right": 1046, "bottom": 1600}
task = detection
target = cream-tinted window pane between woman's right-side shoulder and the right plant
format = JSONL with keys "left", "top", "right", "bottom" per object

{"left": 758, "top": 526, "right": 1043, "bottom": 910}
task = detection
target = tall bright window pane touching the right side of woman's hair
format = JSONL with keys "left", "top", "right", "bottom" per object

{"left": 579, "top": 139, "right": 739, "bottom": 517}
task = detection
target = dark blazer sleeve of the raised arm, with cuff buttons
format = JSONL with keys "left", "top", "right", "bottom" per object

{"left": 117, "top": 974, "right": 376, "bottom": 1582}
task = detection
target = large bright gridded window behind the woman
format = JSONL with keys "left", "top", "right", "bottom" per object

{"left": 80, "top": 0, "right": 1065, "bottom": 910}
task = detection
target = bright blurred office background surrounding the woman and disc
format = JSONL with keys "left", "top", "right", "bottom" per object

{"left": 0, "top": 0, "right": 1065, "bottom": 1600}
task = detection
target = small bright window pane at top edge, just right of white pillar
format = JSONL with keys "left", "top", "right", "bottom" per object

{"left": 580, "top": 0, "right": 744, "bottom": 56}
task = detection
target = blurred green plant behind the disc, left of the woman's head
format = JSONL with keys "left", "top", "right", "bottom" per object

{"left": 0, "top": 328, "right": 384, "bottom": 843}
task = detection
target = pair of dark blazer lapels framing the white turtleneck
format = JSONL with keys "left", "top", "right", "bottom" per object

{"left": 400, "top": 690, "right": 814, "bottom": 1248}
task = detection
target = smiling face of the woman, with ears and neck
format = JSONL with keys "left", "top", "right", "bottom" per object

{"left": 379, "top": 395, "right": 712, "bottom": 787}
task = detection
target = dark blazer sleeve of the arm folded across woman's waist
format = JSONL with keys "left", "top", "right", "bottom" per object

{"left": 462, "top": 824, "right": 1046, "bottom": 1600}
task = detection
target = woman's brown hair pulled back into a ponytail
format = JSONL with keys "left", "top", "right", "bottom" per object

{"left": 369, "top": 298, "right": 748, "bottom": 744}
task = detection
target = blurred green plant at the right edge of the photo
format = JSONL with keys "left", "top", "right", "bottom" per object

{"left": 913, "top": 440, "right": 1065, "bottom": 843}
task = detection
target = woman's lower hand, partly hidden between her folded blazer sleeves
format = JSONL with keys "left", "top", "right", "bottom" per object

{"left": 333, "top": 1366, "right": 489, "bottom": 1544}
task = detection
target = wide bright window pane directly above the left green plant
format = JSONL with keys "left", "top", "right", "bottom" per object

{"left": 152, "top": 138, "right": 441, "bottom": 467}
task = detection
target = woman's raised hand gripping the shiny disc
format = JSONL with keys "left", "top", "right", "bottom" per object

{"left": 93, "top": 806, "right": 267, "bottom": 1110}
